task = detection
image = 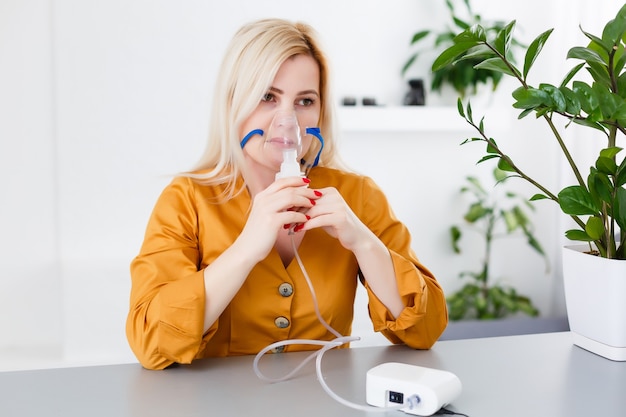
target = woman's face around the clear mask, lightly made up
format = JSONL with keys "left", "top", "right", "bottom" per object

{"left": 239, "top": 55, "right": 321, "bottom": 175}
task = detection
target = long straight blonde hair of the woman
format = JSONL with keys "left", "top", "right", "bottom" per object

{"left": 182, "top": 19, "right": 342, "bottom": 198}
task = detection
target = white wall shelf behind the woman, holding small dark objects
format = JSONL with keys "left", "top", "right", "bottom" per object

{"left": 338, "top": 106, "right": 508, "bottom": 133}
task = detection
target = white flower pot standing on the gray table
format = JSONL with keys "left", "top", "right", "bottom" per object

{"left": 563, "top": 245, "right": 626, "bottom": 361}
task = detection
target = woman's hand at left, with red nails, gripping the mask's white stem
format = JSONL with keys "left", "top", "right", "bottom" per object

{"left": 237, "top": 177, "right": 320, "bottom": 261}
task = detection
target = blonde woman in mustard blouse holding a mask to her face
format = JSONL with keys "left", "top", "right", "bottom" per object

{"left": 127, "top": 19, "right": 447, "bottom": 369}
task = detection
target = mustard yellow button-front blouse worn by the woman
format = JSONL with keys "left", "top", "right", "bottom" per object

{"left": 126, "top": 167, "right": 448, "bottom": 369}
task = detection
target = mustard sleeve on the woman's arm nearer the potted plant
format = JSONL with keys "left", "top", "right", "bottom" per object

{"left": 354, "top": 178, "right": 448, "bottom": 349}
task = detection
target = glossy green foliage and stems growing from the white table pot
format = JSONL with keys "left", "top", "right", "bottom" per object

{"left": 433, "top": 5, "right": 626, "bottom": 260}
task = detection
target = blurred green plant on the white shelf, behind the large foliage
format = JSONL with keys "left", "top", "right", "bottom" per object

{"left": 402, "top": 0, "right": 517, "bottom": 97}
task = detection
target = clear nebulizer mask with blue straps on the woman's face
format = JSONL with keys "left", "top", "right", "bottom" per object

{"left": 241, "top": 111, "right": 324, "bottom": 179}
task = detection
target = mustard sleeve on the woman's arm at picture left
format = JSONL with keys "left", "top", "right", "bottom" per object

{"left": 126, "top": 179, "right": 215, "bottom": 369}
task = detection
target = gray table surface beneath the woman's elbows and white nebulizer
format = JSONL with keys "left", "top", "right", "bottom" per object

{"left": 0, "top": 332, "right": 626, "bottom": 417}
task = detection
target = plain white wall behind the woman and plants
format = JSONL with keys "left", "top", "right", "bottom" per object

{"left": 0, "top": 0, "right": 620, "bottom": 365}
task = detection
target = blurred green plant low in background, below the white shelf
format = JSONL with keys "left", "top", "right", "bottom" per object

{"left": 447, "top": 168, "right": 545, "bottom": 320}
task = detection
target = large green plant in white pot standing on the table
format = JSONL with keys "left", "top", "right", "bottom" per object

{"left": 433, "top": 5, "right": 626, "bottom": 360}
